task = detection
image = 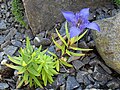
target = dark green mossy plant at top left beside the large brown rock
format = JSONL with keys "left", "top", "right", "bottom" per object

{"left": 11, "top": 0, "right": 27, "bottom": 28}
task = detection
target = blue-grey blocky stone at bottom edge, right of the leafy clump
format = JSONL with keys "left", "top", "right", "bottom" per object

{"left": 66, "top": 76, "right": 79, "bottom": 90}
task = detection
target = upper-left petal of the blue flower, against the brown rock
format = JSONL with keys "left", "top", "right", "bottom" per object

{"left": 62, "top": 11, "right": 75, "bottom": 22}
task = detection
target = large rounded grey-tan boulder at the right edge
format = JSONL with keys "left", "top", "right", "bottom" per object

{"left": 92, "top": 13, "right": 120, "bottom": 74}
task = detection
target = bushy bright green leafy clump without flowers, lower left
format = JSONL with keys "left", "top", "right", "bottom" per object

{"left": 6, "top": 37, "right": 58, "bottom": 88}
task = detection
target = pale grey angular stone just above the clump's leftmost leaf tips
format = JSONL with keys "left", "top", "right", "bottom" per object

{"left": 3, "top": 46, "right": 18, "bottom": 56}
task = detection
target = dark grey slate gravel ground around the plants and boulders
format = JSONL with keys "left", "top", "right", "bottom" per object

{"left": 0, "top": 0, "right": 120, "bottom": 90}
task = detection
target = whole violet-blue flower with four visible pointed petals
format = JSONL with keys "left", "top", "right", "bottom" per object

{"left": 62, "top": 8, "right": 100, "bottom": 38}
